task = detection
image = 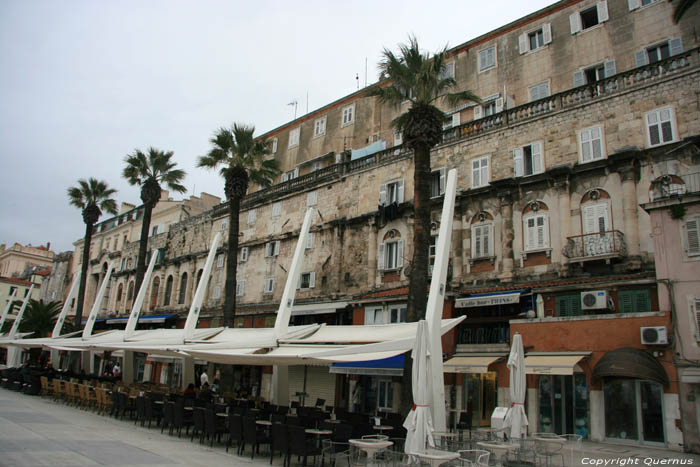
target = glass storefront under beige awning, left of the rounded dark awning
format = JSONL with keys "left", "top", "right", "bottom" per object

{"left": 539, "top": 373, "right": 589, "bottom": 439}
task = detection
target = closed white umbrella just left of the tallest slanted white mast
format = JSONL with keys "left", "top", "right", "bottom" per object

{"left": 403, "top": 320, "right": 434, "bottom": 454}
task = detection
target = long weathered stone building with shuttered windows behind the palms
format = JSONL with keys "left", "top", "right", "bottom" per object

{"left": 63, "top": 0, "right": 700, "bottom": 449}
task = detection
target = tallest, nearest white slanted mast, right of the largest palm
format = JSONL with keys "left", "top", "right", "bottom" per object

{"left": 425, "top": 169, "right": 457, "bottom": 431}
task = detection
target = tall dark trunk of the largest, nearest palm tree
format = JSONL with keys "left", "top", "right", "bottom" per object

{"left": 401, "top": 144, "right": 430, "bottom": 415}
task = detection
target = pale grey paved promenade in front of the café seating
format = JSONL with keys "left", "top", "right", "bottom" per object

{"left": 0, "top": 388, "right": 700, "bottom": 467}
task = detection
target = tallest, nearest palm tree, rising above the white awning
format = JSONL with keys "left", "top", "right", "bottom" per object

{"left": 369, "top": 36, "right": 479, "bottom": 321}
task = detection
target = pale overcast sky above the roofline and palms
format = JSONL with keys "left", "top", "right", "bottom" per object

{"left": 0, "top": 0, "right": 554, "bottom": 252}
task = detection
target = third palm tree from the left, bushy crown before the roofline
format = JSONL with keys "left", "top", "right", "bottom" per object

{"left": 197, "top": 123, "right": 279, "bottom": 327}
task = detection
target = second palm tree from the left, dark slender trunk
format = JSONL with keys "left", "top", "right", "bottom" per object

{"left": 122, "top": 148, "right": 187, "bottom": 290}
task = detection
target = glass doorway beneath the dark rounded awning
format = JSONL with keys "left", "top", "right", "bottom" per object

{"left": 604, "top": 379, "right": 666, "bottom": 446}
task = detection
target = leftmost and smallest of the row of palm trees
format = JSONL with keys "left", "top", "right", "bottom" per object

{"left": 68, "top": 178, "right": 117, "bottom": 331}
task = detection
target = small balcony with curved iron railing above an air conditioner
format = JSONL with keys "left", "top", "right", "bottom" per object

{"left": 562, "top": 230, "right": 627, "bottom": 262}
